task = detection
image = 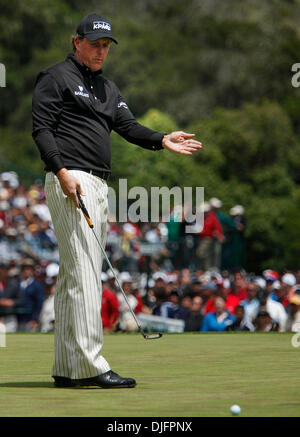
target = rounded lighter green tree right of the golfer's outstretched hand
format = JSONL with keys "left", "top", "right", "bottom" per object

{"left": 189, "top": 101, "right": 300, "bottom": 271}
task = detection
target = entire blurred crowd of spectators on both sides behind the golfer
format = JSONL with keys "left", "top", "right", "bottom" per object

{"left": 0, "top": 172, "right": 300, "bottom": 332}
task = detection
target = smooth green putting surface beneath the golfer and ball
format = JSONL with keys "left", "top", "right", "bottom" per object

{"left": 0, "top": 333, "right": 300, "bottom": 417}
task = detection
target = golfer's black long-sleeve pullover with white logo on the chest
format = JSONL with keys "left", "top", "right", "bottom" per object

{"left": 32, "top": 54, "right": 164, "bottom": 174}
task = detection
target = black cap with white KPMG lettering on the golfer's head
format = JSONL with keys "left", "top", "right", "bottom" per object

{"left": 77, "top": 14, "right": 118, "bottom": 44}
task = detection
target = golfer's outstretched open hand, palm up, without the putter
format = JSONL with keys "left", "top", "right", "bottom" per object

{"left": 162, "top": 131, "right": 202, "bottom": 155}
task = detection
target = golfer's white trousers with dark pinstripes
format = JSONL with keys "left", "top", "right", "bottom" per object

{"left": 45, "top": 170, "right": 110, "bottom": 379}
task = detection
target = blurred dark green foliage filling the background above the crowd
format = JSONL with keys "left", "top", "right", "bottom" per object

{"left": 0, "top": 0, "right": 300, "bottom": 271}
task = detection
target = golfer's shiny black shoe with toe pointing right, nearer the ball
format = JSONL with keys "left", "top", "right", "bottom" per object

{"left": 71, "top": 370, "right": 136, "bottom": 388}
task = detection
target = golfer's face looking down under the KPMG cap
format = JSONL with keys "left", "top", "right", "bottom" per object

{"left": 74, "top": 37, "right": 111, "bottom": 71}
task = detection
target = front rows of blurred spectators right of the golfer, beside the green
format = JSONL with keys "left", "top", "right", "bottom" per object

{"left": 103, "top": 269, "right": 300, "bottom": 332}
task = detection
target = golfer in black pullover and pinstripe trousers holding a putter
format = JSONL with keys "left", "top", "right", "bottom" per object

{"left": 32, "top": 14, "right": 201, "bottom": 388}
